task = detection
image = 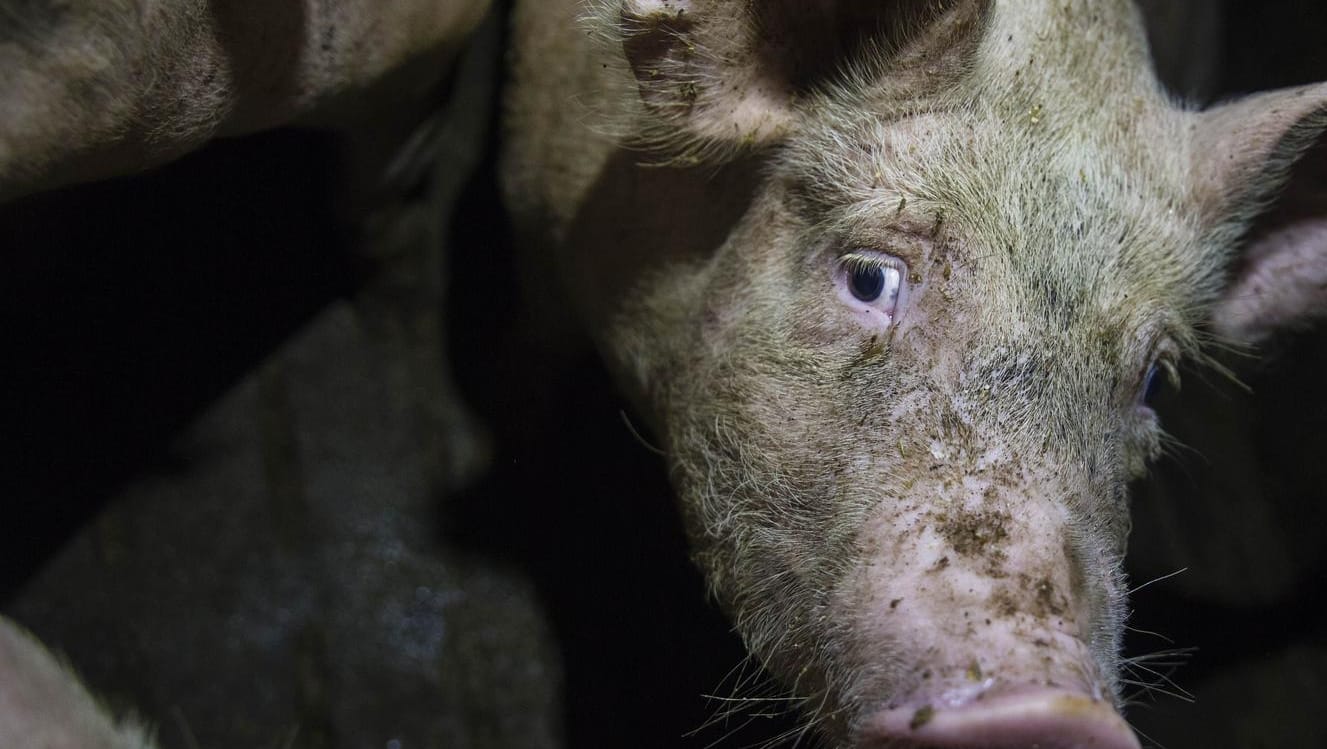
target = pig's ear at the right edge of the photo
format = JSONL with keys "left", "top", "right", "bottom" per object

{"left": 1194, "top": 84, "right": 1327, "bottom": 344}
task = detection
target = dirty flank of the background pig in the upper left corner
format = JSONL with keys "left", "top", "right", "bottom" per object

{"left": 0, "top": 0, "right": 488, "bottom": 201}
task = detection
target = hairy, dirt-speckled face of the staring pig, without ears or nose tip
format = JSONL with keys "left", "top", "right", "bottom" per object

{"left": 644, "top": 110, "right": 1214, "bottom": 743}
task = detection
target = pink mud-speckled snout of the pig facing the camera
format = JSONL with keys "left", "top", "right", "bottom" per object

{"left": 841, "top": 478, "right": 1139, "bottom": 749}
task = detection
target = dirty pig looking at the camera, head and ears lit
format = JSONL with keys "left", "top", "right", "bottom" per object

{"left": 500, "top": 0, "right": 1327, "bottom": 749}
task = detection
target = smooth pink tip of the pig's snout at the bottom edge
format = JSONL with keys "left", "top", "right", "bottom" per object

{"left": 855, "top": 689, "right": 1139, "bottom": 749}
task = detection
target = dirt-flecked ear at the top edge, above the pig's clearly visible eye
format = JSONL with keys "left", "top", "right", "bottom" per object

{"left": 618, "top": 0, "right": 989, "bottom": 156}
